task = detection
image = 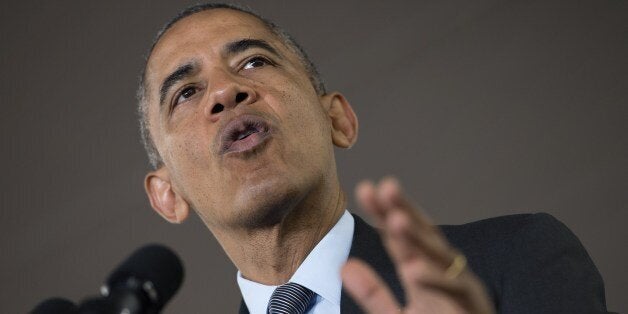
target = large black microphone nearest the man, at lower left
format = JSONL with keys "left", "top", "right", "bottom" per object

{"left": 79, "top": 244, "right": 183, "bottom": 314}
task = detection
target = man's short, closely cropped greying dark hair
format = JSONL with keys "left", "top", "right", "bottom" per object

{"left": 137, "top": 3, "right": 326, "bottom": 169}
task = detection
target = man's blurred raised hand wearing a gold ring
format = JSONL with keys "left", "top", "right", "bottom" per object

{"left": 342, "top": 178, "right": 495, "bottom": 314}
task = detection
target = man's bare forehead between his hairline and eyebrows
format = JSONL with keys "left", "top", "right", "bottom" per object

{"left": 146, "top": 8, "right": 284, "bottom": 90}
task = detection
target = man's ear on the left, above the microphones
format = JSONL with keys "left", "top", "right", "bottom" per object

{"left": 144, "top": 166, "right": 190, "bottom": 223}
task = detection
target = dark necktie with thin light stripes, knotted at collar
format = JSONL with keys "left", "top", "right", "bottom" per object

{"left": 268, "top": 282, "right": 314, "bottom": 314}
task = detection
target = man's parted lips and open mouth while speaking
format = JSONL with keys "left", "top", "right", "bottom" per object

{"left": 220, "top": 115, "right": 270, "bottom": 154}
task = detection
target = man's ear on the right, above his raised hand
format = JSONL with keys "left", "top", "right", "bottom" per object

{"left": 321, "top": 92, "right": 358, "bottom": 148}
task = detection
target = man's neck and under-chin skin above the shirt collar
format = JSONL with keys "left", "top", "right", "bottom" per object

{"left": 210, "top": 179, "right": 346, "bottom": 285}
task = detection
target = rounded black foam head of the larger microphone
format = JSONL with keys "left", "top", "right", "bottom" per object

{"left": 105, "top": 244, "right": 184, "bottom": 310}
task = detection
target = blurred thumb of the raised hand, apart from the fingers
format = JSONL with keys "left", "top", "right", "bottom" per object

{"left": 341, "top": 259, "right": 399, "bottom": 314}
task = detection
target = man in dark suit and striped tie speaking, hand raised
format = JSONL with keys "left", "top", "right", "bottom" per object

{"left": 138, "top": 5, "right": 606, "bottom": 313}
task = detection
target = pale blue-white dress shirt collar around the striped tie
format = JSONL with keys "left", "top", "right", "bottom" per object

{"left": 238, "top": 210, "right": 354, "bottom": 314}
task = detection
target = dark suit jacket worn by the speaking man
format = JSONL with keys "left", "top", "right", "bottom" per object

{"left": 240, "top": 214, "right": 607, "bottom": 314}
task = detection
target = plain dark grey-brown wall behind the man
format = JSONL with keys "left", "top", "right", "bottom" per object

{"left": 0, "top": 0, "right": 628, "bottom": 313}
